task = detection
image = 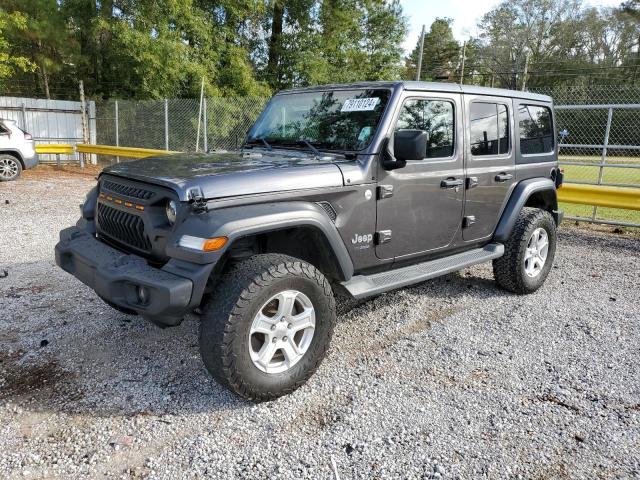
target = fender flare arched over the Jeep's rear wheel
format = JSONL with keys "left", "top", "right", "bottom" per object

{"left": 493, "top": 178, "right": 559, "bottom": 242}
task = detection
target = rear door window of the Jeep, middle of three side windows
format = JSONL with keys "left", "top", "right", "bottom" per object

{"left": 469, "top": 102, "right": 510, "bottom": 157}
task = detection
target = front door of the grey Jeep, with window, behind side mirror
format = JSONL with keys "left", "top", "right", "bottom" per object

{"left": 376, "top": 92, "right": 464, "bottom": 259}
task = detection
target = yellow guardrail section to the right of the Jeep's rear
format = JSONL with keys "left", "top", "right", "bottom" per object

{"left": 558, "top": 183, "right": 640, "bottom": 210}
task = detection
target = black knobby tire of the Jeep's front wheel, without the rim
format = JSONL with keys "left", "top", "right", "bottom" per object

{"left": 200, "top": 254, "right": 336, "bottom": 401}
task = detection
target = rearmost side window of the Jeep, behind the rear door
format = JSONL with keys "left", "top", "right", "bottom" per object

{"left": 518, "top": 105, "right": 553, "bottom": 155}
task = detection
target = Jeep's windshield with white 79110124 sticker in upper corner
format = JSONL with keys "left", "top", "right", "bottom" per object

{"left": 247, "top": 89, "right": 391, "bottom": 151}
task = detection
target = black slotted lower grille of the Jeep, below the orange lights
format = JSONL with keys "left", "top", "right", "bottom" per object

{"left": 97, "top": 202, "right": 151, "bottom": 252}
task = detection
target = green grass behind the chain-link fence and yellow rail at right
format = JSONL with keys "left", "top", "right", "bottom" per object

{"left": 560, "top": 155, "right": 640, "bottom": 224}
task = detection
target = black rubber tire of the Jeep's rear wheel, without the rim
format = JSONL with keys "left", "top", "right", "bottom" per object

{"left": 493, "top": 207, "right": 557, "bottom": 294}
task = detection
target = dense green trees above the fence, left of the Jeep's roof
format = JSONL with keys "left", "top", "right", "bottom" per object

{"left": 0, "top": 0, "right": 406, "bottom": 99}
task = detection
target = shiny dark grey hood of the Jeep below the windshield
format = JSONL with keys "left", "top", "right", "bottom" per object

{"left": 104, "top": 152, "right": 344, "bottom": 201}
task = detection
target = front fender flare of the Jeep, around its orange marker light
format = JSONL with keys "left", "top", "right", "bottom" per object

{"left": 167, "top": 201, "right": 353, "bottom": 280}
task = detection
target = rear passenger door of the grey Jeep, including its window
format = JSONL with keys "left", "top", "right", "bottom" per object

{"left": 462, "top": 95, "right": 515, "bottom": 241}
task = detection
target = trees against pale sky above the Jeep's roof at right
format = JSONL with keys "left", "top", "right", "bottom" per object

{"left": 476, "top": 0, "right": 640, "bottom": 88}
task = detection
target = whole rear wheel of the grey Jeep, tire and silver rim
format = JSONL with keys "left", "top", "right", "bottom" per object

{"left": 493, "top": 208, "right": 557, "bottom": 293}
